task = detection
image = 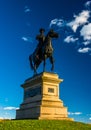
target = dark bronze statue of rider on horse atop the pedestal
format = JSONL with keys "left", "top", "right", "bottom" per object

{"left": 29, "top": 28, "right": 58, "bottom": 75}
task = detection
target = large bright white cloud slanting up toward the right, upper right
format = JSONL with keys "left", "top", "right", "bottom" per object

{"left": 67, "top": 10, "right": 90, "bottom": 32}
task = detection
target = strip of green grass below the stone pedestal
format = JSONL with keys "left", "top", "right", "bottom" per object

{"left": 0, "top": 120, "right": 91, "bottom": 130}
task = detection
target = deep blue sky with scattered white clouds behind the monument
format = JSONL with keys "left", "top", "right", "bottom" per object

{"left": 0, "top": 0, "right": 91, "bottom": 123}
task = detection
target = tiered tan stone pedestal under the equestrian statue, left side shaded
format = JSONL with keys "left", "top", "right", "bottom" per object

{"left": 16, "top": 72, "right": 72, "bottom": 120}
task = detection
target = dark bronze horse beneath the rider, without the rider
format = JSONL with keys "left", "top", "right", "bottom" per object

{"left": 29, "top": 29, "right": 58, "bottom": 74}
